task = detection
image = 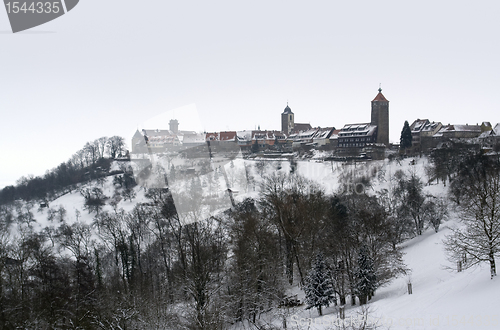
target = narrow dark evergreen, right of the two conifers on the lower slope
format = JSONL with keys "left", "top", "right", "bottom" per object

{"left": 356, "top": 246, "right": 377, "bottom": 305}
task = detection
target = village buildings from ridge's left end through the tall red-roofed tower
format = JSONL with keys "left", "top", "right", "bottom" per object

{"left": 132, "top": 89, "right": 389, "bottom": 158}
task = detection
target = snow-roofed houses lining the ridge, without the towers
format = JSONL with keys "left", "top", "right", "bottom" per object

{"left": 132, "top": 119, "right": 500, "bottom": 157}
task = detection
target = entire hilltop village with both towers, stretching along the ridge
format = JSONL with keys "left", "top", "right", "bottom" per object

{"left": 132, "top": 88, "right": 500, "bottom": 159}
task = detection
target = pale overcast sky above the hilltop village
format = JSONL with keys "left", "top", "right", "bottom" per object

{"left": 0, "top": 0, "right": 500, "bottom": 187}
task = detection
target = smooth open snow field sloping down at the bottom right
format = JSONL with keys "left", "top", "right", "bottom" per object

{"left": 276, "top": 223, "right": 500, "bottom": 330}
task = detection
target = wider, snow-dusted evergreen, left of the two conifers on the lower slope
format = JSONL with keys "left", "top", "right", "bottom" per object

{"left": 304, "top": 253, "right": 335, "bottom": 316}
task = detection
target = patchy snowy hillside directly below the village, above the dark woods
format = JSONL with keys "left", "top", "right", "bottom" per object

{"left": 32, "top": 153, "right": 434, "bottom": 229}
